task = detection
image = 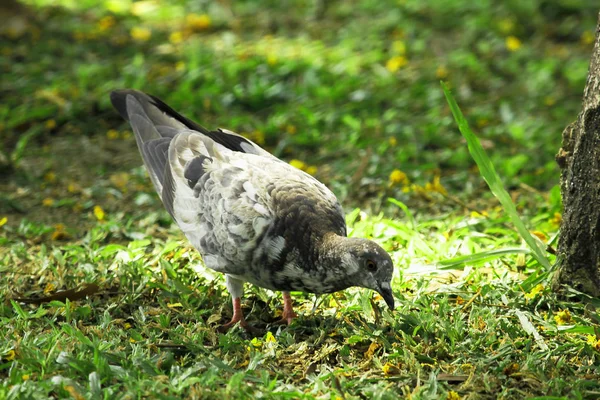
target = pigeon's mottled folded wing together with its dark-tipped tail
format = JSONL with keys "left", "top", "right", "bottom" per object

{"left": 111, "top": 90, "right": 287, "bottom": 275}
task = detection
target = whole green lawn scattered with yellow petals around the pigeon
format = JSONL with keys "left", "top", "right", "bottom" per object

{"left": 0, "top": 0, "right": 600, "bottom": 399}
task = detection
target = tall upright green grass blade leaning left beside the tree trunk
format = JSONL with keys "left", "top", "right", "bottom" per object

{"left": 441, "top": 82, "right": 550, "bottom": 270}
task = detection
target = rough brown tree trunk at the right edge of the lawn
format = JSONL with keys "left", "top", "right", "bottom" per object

{"left": 554, "top": 15, "right": 600, "bottom": 297}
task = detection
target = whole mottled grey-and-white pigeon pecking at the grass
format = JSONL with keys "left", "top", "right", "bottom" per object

{"left": 110, "top": 89, "right": 394, "bottom": 330}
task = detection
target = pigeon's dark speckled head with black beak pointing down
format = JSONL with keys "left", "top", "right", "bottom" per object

{"left": 342, "top": 238, "right": 394, "bottom": 310}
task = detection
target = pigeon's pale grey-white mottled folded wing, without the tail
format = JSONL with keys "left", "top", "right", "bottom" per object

{"left": 163, "top": 131, "right": 289, "bottom": 276}
